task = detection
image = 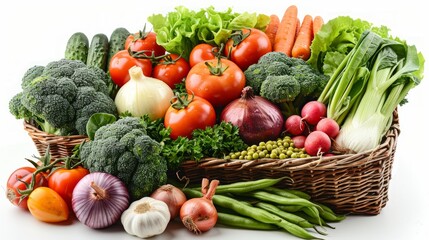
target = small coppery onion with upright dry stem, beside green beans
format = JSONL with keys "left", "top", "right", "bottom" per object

{"left": 180, "top": 179, "right": 219, "bottom": 234}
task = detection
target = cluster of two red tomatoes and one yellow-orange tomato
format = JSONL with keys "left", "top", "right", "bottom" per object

{"left": 7, "top": 155, "right": 89, "bottom": 222}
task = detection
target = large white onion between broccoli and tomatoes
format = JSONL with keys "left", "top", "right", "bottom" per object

{"left": 115, "top": 66, "right": 174, "bottom": 120}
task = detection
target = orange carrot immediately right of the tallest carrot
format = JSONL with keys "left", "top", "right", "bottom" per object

{"left": 292, "top": 15, "right": 313, "bottom": 60}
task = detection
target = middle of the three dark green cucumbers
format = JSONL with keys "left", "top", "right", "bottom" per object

{"left": 86, "top": 33, "right": 109, "bottom": 71}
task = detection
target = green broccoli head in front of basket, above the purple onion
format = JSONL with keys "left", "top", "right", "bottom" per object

{"left": 80, "top": 117, "right": 167, "bottom": 200}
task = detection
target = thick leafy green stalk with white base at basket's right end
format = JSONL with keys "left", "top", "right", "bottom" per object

{"left": 336, "top": 39, "right": 424, "bottom": 152}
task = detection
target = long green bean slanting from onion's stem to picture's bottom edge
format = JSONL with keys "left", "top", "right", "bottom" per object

{"left": 183, "top": 189, "right": 320, "bottom": 239}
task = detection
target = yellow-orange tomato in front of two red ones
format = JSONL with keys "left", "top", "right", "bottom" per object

{"left": 27, "top": 187, "right": 69, "bottom": 223}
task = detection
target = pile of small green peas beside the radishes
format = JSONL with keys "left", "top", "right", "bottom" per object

{"left": 225, "top": 136, "right": 310, "bottom": 160}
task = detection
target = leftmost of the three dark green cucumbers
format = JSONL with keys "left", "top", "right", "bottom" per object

{"left": 64, "top": 32, "right": 89, "bottom": 63}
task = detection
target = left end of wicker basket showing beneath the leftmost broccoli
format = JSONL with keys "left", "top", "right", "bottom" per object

{"left": 24, "top": 121, "right": 88, "bottom": 159}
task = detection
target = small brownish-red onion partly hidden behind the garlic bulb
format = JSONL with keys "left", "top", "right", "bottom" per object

{"left": 150, "top": 184, "right": 186, "bottom": 219}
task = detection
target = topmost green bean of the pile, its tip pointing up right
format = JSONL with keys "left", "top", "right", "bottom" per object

{"left": 216, "top": 177, "right": 288, "bottom": 194}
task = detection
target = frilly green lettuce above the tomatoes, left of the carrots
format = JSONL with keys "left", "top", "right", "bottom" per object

{"left": 148, "top": 6, "right": 270, "bottom": 59}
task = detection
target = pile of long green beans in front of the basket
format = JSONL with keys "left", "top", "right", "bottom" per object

{"left": 182, "top": 178, "right": 345, "bottom": 239}
